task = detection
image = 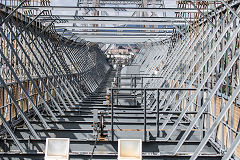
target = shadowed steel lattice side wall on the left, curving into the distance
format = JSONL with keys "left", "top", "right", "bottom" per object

{"left": 0, "top": 0, "right": 110, "bottom": 152}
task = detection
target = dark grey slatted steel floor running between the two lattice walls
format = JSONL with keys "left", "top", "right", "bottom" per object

{"left": 0, "top": 72, "right": 221, "bottom": 160}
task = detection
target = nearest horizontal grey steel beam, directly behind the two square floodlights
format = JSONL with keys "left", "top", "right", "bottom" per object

{"left": 0, "top": 138, "right": 220, "bottom": 160}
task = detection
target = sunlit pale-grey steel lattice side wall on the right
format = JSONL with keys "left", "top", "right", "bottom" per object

{"left": 134, "top": 0, "right": 240, "bottom": 159}
